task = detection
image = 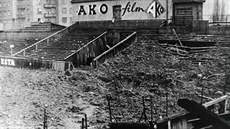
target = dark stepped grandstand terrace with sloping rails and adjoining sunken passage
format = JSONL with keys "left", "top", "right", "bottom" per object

{"left": 9, "top": 20, "right": 135, "bottom": 67}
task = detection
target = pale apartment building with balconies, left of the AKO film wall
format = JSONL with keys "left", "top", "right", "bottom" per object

{"left": 0, "top": 0, "right": 73, "bottom": 30}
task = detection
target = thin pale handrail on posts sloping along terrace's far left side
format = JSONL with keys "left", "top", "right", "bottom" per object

{"left": 12, "top": 26, "right": 71, "bottom": 56}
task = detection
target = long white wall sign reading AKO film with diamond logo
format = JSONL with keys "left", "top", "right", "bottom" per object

{"left": 72, "top": 0, "right": 171, "bottom": 21}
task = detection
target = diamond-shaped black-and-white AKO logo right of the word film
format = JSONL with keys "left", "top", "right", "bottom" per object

{"left": 147, "top": 1, "right": 165, "bottom": 18}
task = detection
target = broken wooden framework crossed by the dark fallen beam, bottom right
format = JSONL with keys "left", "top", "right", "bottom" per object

{"left": 157, "top": 94, "right": 230, "bottom": 129}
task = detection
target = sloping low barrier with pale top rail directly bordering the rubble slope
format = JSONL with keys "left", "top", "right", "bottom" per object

{"left": 91, "top": 32, "right": 136, "bottom": 68}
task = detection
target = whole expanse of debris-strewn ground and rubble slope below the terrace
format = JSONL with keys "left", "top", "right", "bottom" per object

{"left": 0, "top": 35, "right": 230, "bottom": 129}
